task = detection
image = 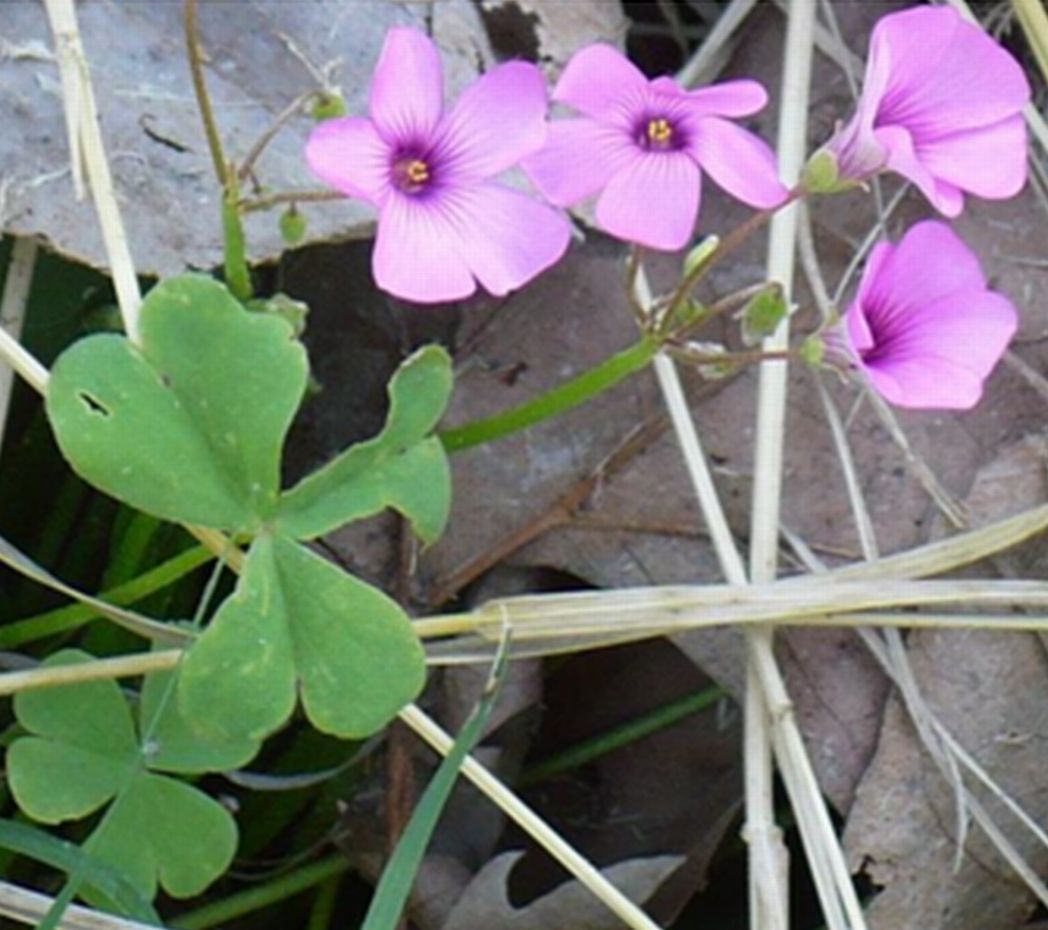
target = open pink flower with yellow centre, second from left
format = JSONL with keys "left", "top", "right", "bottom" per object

{"left": 523, "top": 45, "right": 787, "bottom": 251}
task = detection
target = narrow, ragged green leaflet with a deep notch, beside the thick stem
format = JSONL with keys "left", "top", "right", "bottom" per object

{"left": 278, "top": 346, "right": 453, "bottom": 543}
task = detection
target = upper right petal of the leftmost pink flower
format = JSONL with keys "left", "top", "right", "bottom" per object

{"left": 436, "top": 62, "right": 548, "bottom": 178}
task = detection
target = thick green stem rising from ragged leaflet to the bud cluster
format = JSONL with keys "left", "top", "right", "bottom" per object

{"left": 439, "top": 336, "right": 660, "bottom": 452}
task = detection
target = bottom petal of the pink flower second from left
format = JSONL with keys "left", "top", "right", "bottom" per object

{"left": 596, "top": 152, "right": 701, "bottom": 252}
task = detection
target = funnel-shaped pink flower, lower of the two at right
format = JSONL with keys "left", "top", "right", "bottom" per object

{"left": 831, "top": 220, "right": 1017, "bottom": 410}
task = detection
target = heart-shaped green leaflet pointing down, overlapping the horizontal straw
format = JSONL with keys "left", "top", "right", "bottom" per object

{"left": 178, "top": 535, "right": 425, "bottom": 739}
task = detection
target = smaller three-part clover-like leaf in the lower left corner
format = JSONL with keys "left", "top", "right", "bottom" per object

{"left": 6, "top": 649, "right": 258, "bottom": 899}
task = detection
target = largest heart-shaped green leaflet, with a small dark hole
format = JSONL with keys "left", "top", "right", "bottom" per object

{"left": 47, "top": 275, "right": 307, "bottom": 532}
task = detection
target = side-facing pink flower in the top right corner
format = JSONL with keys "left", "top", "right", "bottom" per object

{"left": 828, "top": 6, "right": 1030, "bottom": 216}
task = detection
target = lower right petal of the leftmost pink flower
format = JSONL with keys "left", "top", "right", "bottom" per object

{"left": 436, "top": 185, "right": 571, "bottom": 297}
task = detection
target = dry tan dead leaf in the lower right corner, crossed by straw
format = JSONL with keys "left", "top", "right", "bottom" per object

{"left": 846, "top": 436, "right": 1048, "bottom": 930}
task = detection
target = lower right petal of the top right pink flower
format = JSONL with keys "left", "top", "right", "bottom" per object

{"left": 918, "top": 114, "right": 1028, "bottom": 200}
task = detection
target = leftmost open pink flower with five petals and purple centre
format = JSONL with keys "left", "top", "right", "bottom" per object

{"left": 306, "top": 28, "right": 570, "bottom": 303}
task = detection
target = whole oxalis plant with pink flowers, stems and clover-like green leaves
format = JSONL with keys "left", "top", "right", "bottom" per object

{"left": 0, "top": 0, "right": 1030, "bottom": 930}
